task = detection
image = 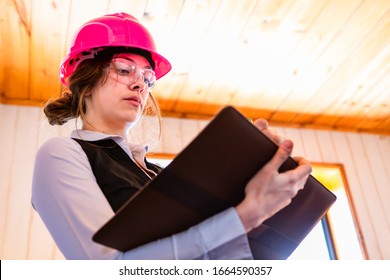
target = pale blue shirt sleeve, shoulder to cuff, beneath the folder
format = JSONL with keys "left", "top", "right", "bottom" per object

{"left": 32, "top": 137, "right": 252, "bottom": 259}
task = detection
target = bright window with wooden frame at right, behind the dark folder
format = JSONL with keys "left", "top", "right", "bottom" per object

{"left": 289, "top": 164, "right": 365, "bottom": 260}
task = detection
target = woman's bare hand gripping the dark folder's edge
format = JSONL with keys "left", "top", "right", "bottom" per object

{"left": 236, "top": 121, "right": 312, "bottom": 232}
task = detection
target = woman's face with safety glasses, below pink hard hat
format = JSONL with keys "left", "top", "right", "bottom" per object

{"left": 85, "top": 53, "right": 155, "bottom": 133}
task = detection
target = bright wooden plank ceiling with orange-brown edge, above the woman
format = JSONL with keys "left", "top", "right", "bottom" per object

{"left": 0, "top": 0, "right": 390, "bottom": 134}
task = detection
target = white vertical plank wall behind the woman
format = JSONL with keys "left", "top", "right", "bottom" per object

{"left": 0, "top": 104, "right": 390, "bottom": 259}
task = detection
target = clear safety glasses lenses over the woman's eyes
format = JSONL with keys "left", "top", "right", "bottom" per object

{"left": 110, "top": 58, "right": 156, "bottom": 88}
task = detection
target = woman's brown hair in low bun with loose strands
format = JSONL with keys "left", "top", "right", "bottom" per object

{"left": 43, "top": 50, "right": 161, "bottom": 146}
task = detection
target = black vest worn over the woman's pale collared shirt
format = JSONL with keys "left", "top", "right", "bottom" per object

{"left": 73, "top": 138, "right": 162, "bottom": 212}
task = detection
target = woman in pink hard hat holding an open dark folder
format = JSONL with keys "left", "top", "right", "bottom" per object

{"left": 32, "top": 13, "right": 311, "bottom": 259}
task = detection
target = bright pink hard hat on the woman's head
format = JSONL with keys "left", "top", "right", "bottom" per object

{"left": 60, "top": 13, "right": 172, "bottom": 86}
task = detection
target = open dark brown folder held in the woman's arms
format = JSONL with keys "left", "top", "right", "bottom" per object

{"left": 93, "top": 106, "right": 336, "bottom": 259}
